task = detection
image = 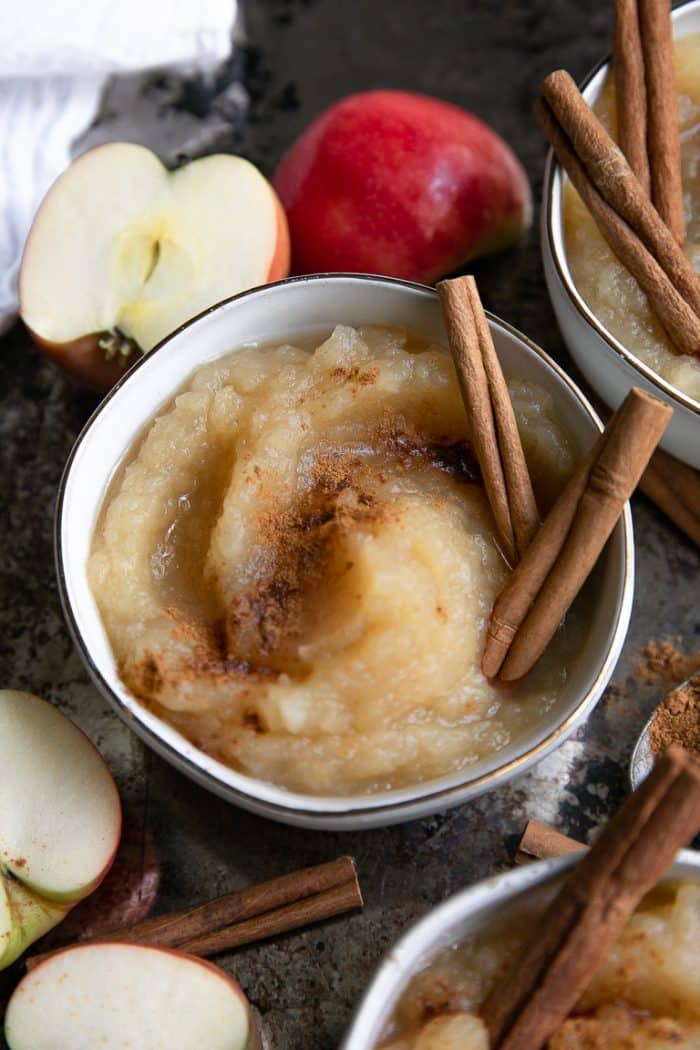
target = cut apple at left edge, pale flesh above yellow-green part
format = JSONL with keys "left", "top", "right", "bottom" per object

{"left": 0, "top": 689, "right": 122, "bottom": 969}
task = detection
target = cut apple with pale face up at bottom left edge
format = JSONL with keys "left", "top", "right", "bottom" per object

{"left": 5, "top": 944, "right": 259, "bottom": 1050}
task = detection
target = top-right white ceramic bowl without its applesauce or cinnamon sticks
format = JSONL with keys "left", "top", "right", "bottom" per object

{"left": 542, "top": 0, "right": 700, "bottom": 468}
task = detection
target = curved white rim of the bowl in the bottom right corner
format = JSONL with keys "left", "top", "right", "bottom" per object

{"left": 340, "top": 849, "right": 700, "bottom": 1050}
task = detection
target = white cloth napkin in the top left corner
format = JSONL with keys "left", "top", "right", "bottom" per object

{"left": 0, "top": 0, "right": 236, "bottom": 332}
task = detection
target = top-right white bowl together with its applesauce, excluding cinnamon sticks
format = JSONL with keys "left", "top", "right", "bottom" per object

{"left": 542, "top": 0, "right": 700, "bottom": 468}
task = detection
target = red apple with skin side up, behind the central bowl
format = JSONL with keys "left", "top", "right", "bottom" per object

{"left": 273, "top": 91, "right": 532, "bottom": 284}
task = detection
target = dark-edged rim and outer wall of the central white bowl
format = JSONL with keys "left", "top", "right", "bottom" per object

{"left": 54, "top": 273, "right": 634, "bottom": 828}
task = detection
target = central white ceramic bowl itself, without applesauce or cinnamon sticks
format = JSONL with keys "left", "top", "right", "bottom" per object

{"left": 56, "top": 275, "right": 634, "bottom": 828}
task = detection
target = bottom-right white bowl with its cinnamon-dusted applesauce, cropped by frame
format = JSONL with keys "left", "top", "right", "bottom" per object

{"left": 342, "top": 849, "right": 700, "bottom": 1050}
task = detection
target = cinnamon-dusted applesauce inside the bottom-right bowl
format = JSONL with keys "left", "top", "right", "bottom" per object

{"left": 380, "top": 882, "right": 700, "bottom": 1050}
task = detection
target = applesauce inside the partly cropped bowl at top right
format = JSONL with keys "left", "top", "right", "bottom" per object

{"left": 564, "top": 33, "right": 700, "bottom": 401}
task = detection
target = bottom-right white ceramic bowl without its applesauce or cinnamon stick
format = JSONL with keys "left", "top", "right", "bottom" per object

{"left": 341, "top": 849, "right": 700, "bottom": 1050}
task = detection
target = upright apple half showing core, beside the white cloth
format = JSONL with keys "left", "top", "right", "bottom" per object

{"left": 20, "top": 142, "right": 290, "bottom": 392}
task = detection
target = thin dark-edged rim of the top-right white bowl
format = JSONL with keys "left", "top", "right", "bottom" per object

{"left": 543, "top": 0, "right": 700, "bottom": 416}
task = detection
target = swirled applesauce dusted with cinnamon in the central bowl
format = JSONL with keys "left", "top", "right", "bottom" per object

{"left": 89, "top": 327, "right": 575, "bottom": 794}
